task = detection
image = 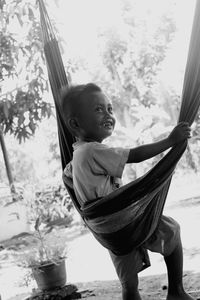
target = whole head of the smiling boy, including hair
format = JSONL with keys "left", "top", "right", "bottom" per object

{"left": 62, "top": 83, "right": 115, "bottom": 142}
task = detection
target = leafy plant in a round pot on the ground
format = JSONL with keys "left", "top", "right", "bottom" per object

{"left": 20, "top": 218, "right": 66, "bottom": 291}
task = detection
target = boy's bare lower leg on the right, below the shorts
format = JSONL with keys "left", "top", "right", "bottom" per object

{"left": 164, "top": 242, "right": 194, "bottom": 300}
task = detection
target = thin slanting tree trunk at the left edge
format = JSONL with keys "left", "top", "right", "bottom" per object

{"left": 0, "top": 129, "right": 16, "bottom": 201}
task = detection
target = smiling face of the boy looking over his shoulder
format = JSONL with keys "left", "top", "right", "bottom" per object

{"left": 73, "top": 92, "right": 115, "bottom": 143}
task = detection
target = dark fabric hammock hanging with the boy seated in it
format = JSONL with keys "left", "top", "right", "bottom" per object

{"left": 39, "top": 0, "right": 200, "bottom": 255}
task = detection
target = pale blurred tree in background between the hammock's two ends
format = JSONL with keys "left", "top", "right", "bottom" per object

{"left": 89, "top": 0, "right": 176, "bottom": 175}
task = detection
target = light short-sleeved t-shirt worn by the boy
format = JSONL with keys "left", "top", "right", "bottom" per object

{"left": 64, "top": 141, "right": 130, "bottom": 204}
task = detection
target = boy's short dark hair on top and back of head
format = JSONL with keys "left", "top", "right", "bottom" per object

{"left": 61, "top": 83, "right": 102, "bottom": 121}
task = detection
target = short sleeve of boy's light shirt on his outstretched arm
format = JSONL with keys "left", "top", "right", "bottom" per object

{"left": 91, "top": 143, "right": 130, "bottom": 178}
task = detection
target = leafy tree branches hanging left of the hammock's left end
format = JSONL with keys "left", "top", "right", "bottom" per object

{"left": 0, "top": 0, "right": 52, "bottom": 142}
